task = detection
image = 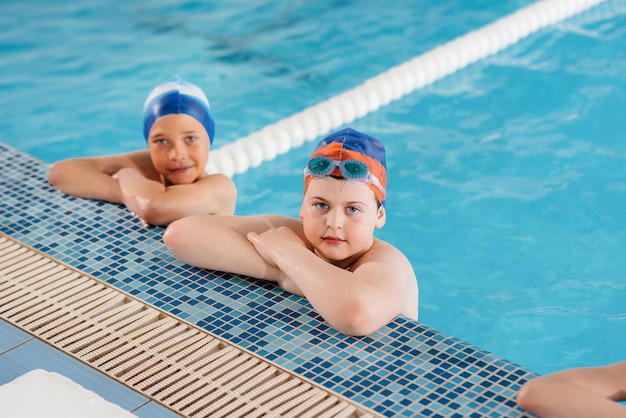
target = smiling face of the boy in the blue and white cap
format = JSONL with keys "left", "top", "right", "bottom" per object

{"left": 148, "top": 114, "right": 211, "bottom": 184}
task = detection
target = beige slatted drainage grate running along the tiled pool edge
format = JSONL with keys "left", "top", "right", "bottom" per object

{"left": 0, "top": 233, "right": 374, "bottom": 417}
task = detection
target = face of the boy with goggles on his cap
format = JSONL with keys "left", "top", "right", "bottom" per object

{"left": 300, "top": 177, "right": 386, "bottom": 267}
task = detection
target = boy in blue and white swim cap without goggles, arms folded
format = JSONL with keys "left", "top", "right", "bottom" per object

{"left": 48, "top": 79, "right": 237, "bottom": 225}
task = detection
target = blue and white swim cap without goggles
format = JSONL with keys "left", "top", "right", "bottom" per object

{"left": 143, "top": 79, "right": 215, "bottom": 144}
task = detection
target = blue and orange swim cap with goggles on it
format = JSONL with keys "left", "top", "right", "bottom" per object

{"left": 304, "top": 128, "right": 387, "bottom": 204}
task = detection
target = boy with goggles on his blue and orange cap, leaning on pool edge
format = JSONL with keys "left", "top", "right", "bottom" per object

{"left": 164, "top": 129, "right": 418, "bottom": 335}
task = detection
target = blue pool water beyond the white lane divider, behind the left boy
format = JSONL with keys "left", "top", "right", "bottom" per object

{"left": 0, "top": 0, "right": 530, "bottom": 161}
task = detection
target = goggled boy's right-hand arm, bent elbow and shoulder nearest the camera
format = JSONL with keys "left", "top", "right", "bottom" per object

{"left": 249, "top": 228, "right": 417, "bottom": 335}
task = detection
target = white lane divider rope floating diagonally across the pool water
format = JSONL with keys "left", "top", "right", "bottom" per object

{"left": 207, "top": 0, "right": 605, "bottom": 177}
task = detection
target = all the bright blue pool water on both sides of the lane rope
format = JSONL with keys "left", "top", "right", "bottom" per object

{"left": 0, "top": 0, "right": 626, "bottom": 373}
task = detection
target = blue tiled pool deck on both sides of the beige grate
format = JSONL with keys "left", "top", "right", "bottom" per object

{"left": 0, "top": 143, "right": 534, "bottom": 417}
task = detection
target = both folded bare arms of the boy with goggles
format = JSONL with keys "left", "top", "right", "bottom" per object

{"left": 163, "top": 215, "right": 417, "bottom": 335}
